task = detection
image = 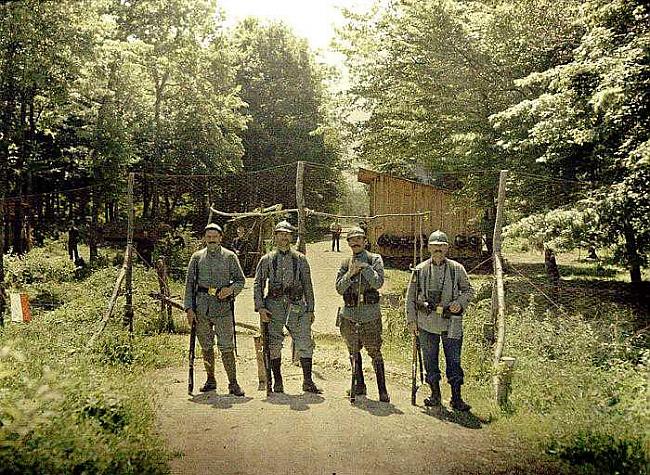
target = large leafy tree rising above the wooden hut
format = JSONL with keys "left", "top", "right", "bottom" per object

{"left": 338, "top": 0, "right": 577, "bottom": 251}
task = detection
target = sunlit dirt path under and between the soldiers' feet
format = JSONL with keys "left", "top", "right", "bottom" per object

{"left": 156, "top": 243, "right": 553, "bottom": 474}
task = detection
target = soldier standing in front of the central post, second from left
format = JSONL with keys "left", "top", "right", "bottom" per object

{"left": 253, "top": 221, "right": 322, "bottom": 394}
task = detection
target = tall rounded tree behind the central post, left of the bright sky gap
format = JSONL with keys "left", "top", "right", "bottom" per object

{"left": 233, "top": 18, "right": 339, "bottom": 209}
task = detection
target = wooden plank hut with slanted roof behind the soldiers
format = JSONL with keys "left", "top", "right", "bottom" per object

{"left": 357, "top": 168, "right": 483, "bottom": 260}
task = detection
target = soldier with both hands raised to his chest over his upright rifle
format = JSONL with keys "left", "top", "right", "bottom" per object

{"left": 336, "top": 227, "right": 390, "bottom": 402}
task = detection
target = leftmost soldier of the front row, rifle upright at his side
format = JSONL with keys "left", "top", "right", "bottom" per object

{"left": 184, "top": 223, "right": 245, "bottom": 396}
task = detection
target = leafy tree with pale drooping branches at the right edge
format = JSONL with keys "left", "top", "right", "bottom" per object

{"left": 494, "top": 0, "right": 650, "bottom": 283}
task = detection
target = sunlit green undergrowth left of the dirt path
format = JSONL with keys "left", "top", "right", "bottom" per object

{"left": 0, "top": 243, "right": 183, "bottom": 474}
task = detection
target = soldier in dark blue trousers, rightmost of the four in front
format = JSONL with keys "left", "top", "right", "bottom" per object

{"left": 406, "top": 231, "right": 474, "bottom": 411}
